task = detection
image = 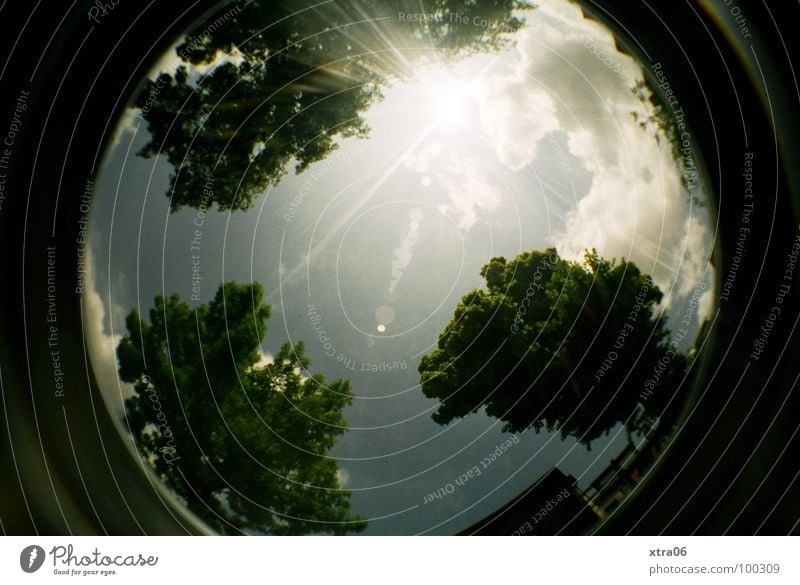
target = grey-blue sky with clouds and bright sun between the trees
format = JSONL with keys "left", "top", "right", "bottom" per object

{"left": 85, "top": 0, "right": 713, "bottom": 534}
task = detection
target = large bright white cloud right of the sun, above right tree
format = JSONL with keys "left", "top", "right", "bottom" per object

{"left": 479, "top": 0, "right": 709, "bottom": 296}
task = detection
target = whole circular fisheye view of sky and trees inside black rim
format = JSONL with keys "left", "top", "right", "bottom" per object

{"left": 81, "top": 0, "right": 719, "bottom": 535}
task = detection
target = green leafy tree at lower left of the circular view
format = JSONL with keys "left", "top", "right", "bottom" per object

{"left": 117, "top": 283, "right": 366, "bottom": 534}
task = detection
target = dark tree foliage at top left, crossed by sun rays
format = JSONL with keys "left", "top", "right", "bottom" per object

{"left": 136, "top": 0, "right": 525, "bottom": 211}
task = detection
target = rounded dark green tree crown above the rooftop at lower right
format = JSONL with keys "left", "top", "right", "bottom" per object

{"left": 419, "top": 248, "right": 688, "bottom": 446}
